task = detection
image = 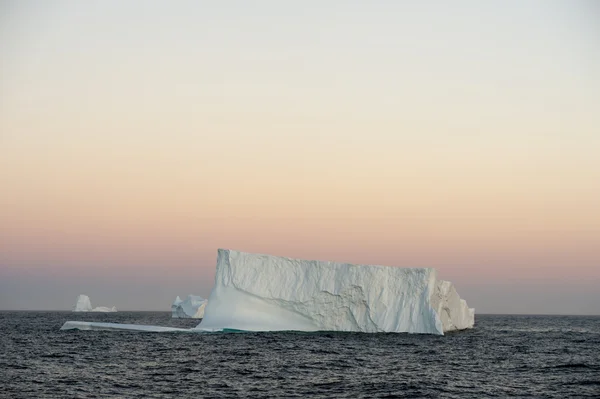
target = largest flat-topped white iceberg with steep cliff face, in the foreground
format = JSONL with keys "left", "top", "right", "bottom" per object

{"left": 196, "top": 249, "right": 474, "bottom": 334}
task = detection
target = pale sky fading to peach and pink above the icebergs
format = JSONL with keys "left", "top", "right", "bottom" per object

{"left": 0, "top": 0, "right": 600, "bottom": 314}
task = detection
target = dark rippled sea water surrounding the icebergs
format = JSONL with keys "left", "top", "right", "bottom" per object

{"left": 0, "top": 312, "right": 600, "bottom": 398}
